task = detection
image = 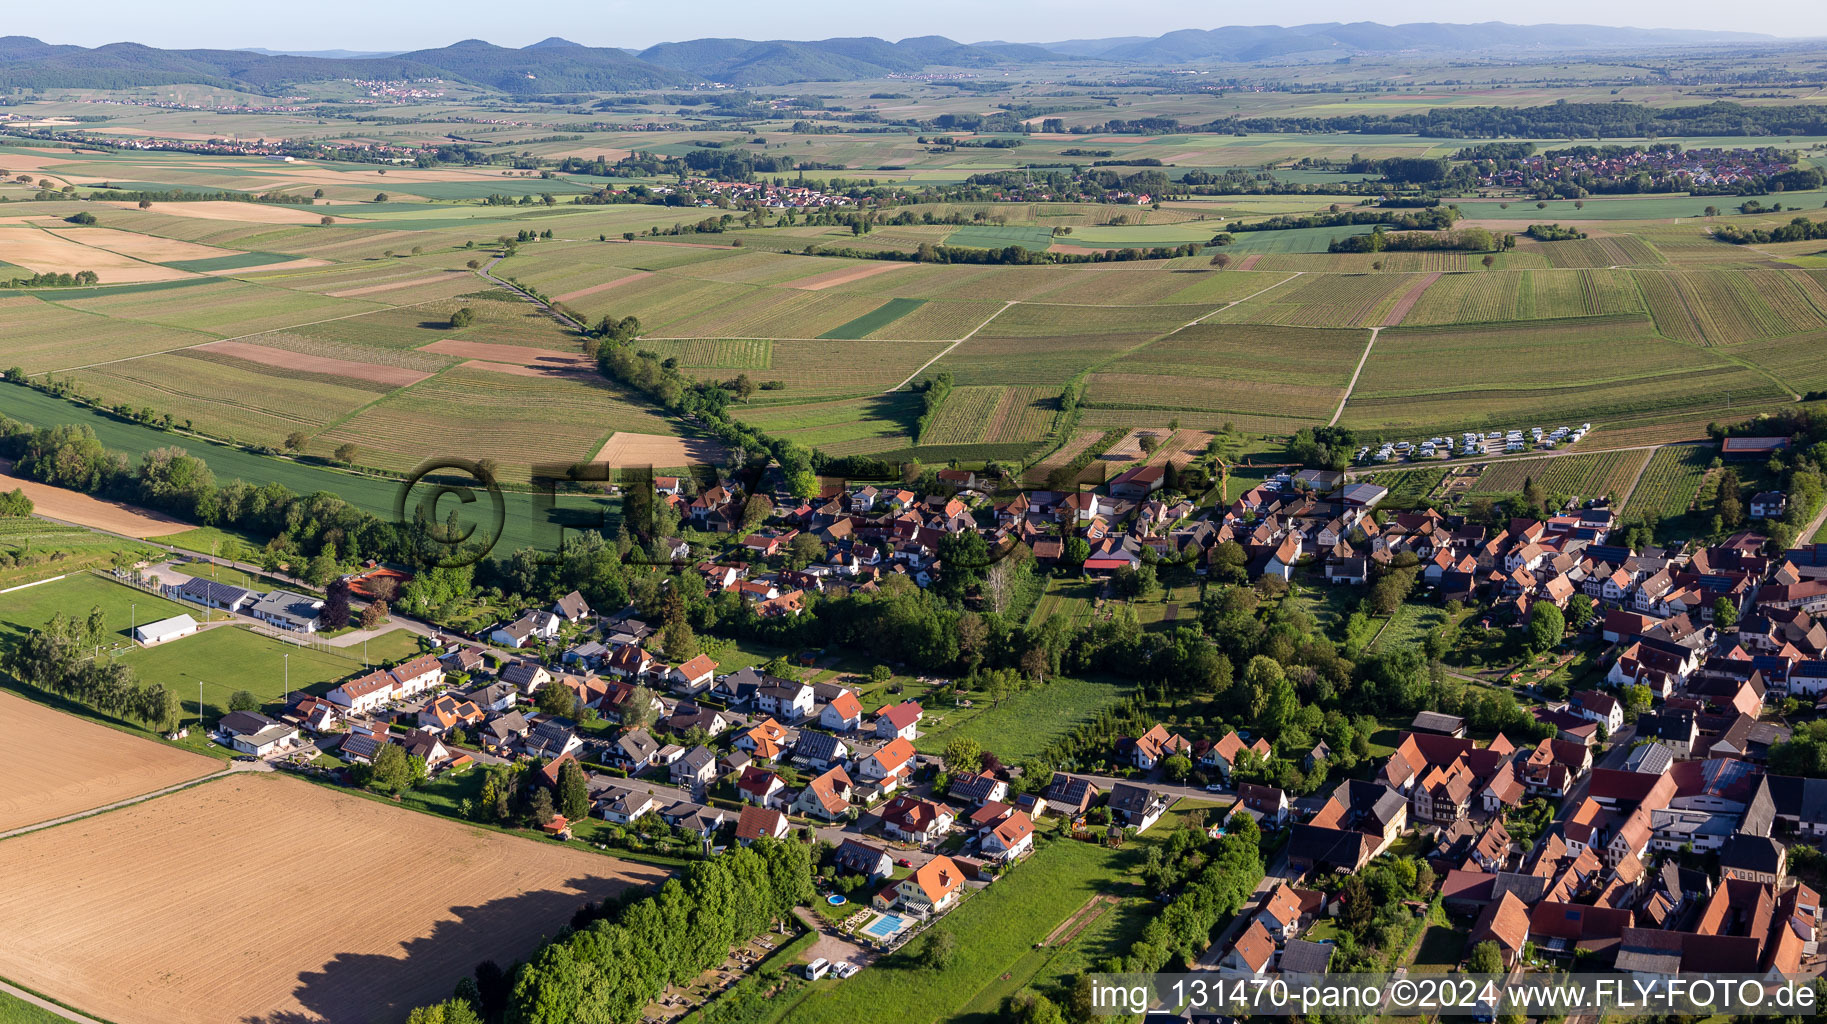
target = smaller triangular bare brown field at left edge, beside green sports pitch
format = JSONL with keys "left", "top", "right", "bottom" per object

{"left": 0, "top": 691, "right": 223, "bottom": 832}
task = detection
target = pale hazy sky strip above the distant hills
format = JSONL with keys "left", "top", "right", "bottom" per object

{"left": 14, "top": 0, "right": 1827, "bottom": 49}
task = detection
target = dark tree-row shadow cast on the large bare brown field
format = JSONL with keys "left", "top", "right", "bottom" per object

{"left": 241, "top": 861, "right": 669, "bottom": 1024}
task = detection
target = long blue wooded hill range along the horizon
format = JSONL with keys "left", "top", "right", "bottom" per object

{"left": 0, "top": 22, "right": 1772, "bottom": 95}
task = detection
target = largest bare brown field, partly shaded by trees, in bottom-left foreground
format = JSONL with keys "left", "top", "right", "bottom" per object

{"left": 0, "top": 773, "right": 665, "bottom": 1024}
